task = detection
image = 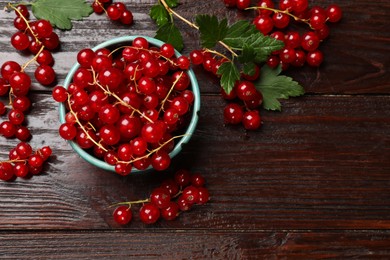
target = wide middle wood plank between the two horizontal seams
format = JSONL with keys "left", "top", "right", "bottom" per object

{"left": 0, "top": 94, "right": 390, "bottom": 230}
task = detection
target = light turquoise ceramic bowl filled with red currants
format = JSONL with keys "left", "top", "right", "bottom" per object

{"left": 59, "top": 35, "right": 200, "bottom": 173}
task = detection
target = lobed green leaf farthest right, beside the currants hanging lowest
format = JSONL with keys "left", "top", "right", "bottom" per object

{"left": 255, "top": 65, "right": 305, "bottom": 111}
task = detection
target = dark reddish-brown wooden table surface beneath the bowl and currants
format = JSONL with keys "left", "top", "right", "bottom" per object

{"left": 0, "top": 0, "right": 390, "bottom": 259}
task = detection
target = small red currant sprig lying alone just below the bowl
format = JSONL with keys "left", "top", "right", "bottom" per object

{"left": 113, "top": 169, "right": 210, "bottom": 225}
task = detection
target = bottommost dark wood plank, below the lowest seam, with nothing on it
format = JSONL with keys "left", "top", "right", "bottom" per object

{"left": 0, "top": 229, "right": 390, "bottom": 259}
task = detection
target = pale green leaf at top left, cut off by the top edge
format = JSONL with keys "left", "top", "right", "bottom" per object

{"left": 31, "top": 0, "right": 93, "bottom": 30}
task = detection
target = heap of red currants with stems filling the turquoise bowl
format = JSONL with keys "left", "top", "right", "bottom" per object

{"left": 53, "top": 37, "right": 194, "bottom": 175}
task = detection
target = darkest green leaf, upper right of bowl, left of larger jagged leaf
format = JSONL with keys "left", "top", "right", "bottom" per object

{"left": 195, "top": 14, "right": 228, "bottom": 48}
